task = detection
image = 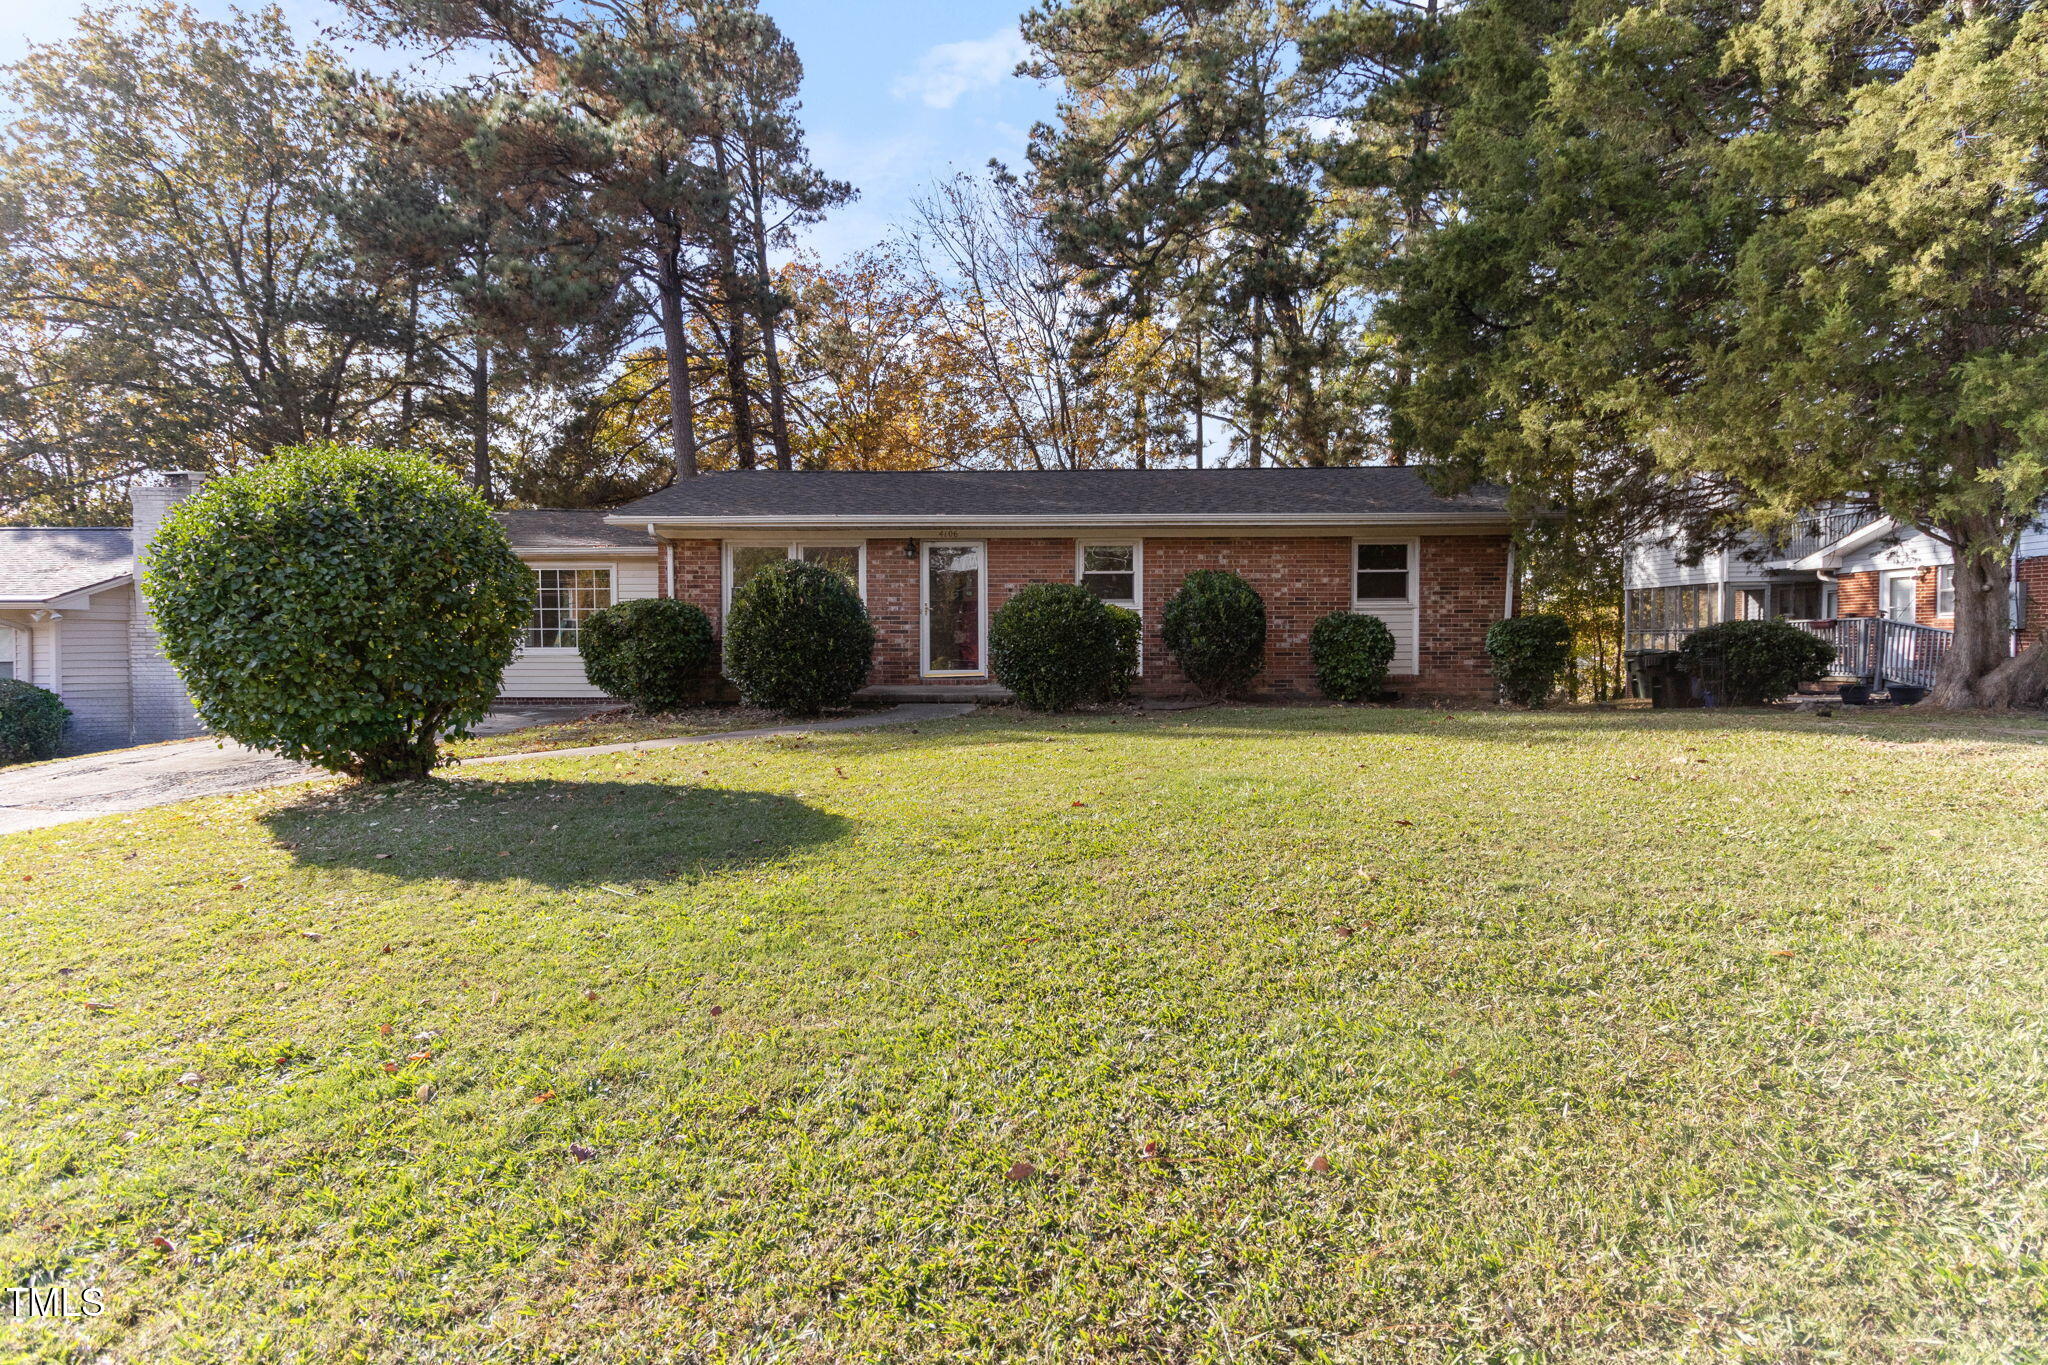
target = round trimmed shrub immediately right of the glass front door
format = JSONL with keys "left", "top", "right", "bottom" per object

{"left": 989, "top": 583, "right": 1137, "bottom": 710}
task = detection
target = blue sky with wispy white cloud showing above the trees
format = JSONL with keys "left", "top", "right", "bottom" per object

{"left": 0, "top": 0, "right": 1053, "bottom": 260}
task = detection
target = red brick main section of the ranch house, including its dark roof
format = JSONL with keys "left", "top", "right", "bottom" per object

{"left": 608, "top": 467, "right": 1513, "bottom": 698}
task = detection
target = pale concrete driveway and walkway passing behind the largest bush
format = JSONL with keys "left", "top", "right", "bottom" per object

{"left": 0, "top": 704, "right": 973, "bottom": 835}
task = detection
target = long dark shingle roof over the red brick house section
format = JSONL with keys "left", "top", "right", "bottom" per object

{"left": 612, "top": 467, "right": 1507, "bottom": 522}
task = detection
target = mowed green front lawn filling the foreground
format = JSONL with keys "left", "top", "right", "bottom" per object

{"left": 0, "top": 710, "right": 2048, "bottom": 1363}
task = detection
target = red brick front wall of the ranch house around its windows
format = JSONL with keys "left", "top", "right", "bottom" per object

{"left": 672, "top": 536, "right": 1507, "bottom": 698}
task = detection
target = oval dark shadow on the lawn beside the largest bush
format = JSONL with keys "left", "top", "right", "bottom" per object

{"left": 262, "top": 780, "right": 852, "bottom": 888}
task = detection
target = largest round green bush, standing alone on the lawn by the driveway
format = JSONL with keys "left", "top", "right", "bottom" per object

{"left": 141, "top": 446, "right": 532, "bottom": 782}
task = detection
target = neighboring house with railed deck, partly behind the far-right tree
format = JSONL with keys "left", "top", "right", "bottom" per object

{"left": 1622, "top": 512, "right": 2048, "bottom": 686}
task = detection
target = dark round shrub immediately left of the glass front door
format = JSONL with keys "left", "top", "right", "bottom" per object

{"left": 725, "top": 559, "right": 874, "bottom": 716}
